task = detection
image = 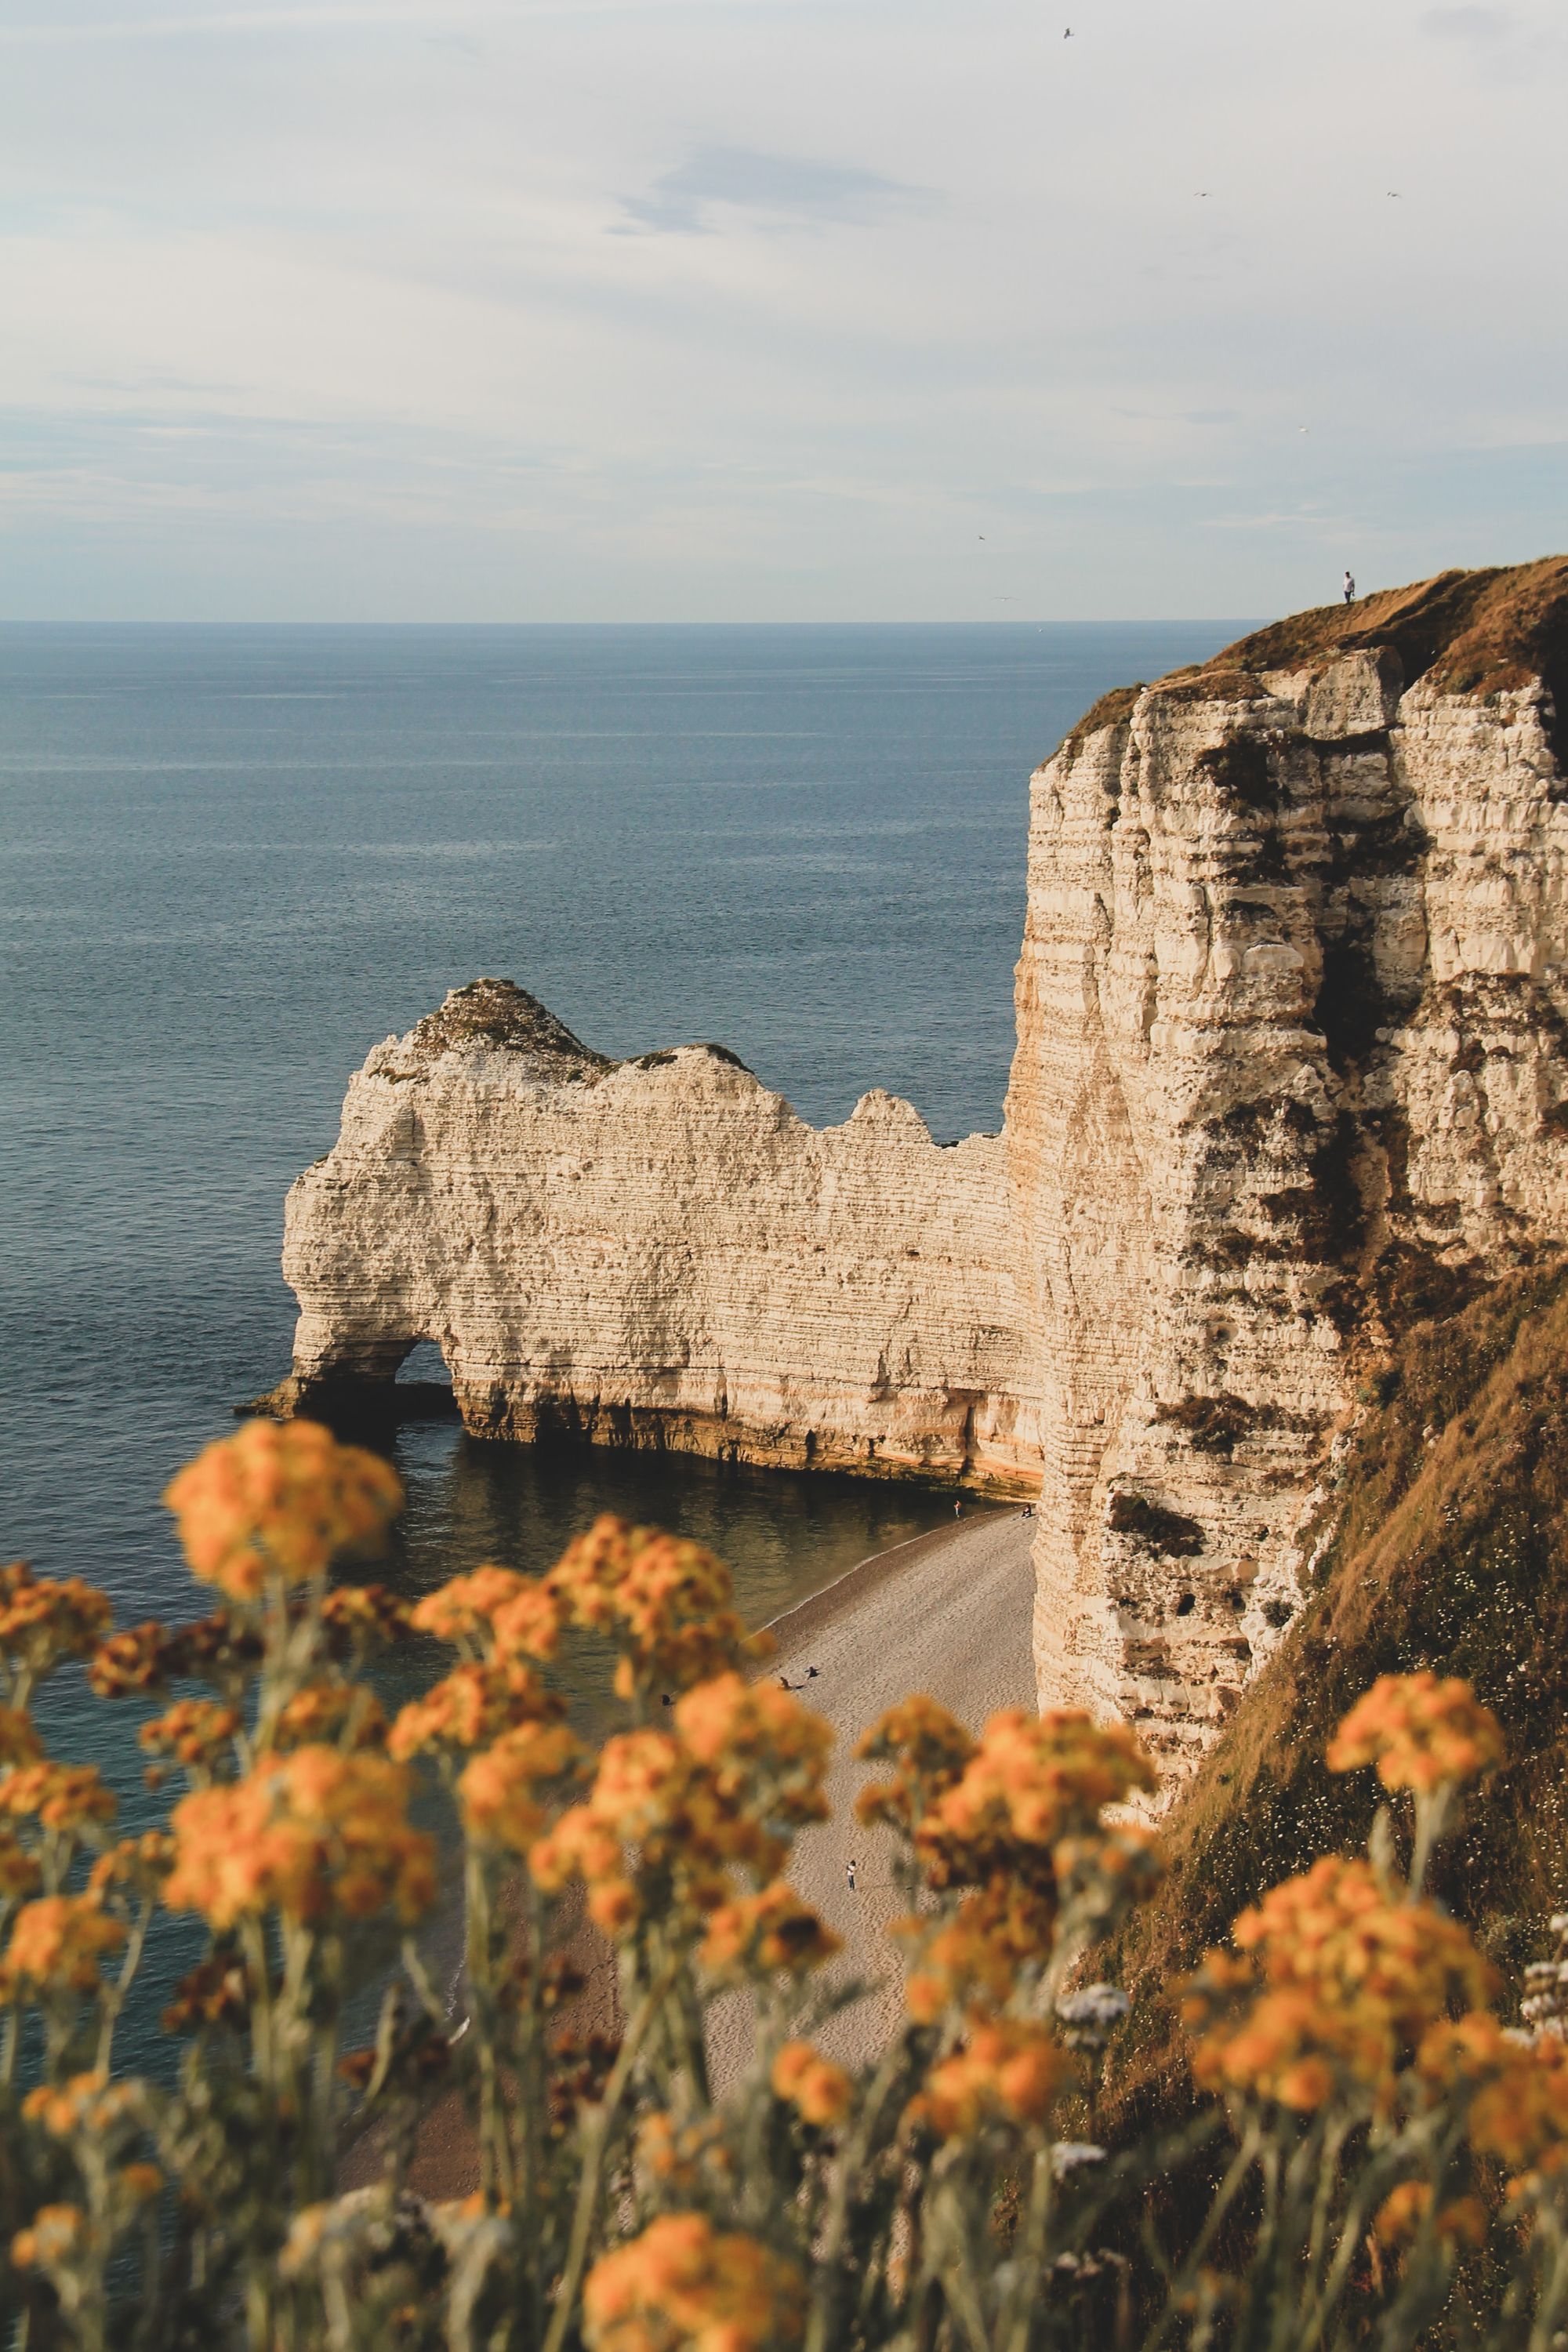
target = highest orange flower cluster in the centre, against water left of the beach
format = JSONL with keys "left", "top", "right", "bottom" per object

{"left": 546, "top": 1512, "right": 771, "bottom": 1698}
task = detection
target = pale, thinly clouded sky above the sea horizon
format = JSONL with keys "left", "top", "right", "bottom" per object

{"left": 0, "top": 0, "right": 1568, "bottom": 621}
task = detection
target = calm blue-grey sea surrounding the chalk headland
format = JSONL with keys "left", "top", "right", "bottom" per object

{"left": 0, "top": 623, "right": 1241, "bottom": 2056}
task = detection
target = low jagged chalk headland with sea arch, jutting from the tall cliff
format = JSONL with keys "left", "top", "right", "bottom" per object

{"left": 285, "top": 981, "right": 1036, "bottom": 1489}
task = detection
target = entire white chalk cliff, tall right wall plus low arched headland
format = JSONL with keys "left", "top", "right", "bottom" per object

{"left": 278, "top": 560, "right": 1568, "bottom": 1769}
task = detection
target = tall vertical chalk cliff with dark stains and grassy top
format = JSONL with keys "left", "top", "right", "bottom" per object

{"left": 1006, "top": 564, "right": 1568, "bottom": 1764}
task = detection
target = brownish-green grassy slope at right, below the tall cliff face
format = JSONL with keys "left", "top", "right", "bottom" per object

{"left": 1116, "top": 1258, "right": 1568, "bottom": 2122}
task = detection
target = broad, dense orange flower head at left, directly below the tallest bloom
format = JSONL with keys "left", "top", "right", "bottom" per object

{"left": 165, "top": 1748, "right": 435, "bottom": 1931}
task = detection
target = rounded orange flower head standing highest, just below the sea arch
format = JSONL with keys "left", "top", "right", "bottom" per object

{"left": 165, "top": 1421, "right": 402, "bottom": 1602}
